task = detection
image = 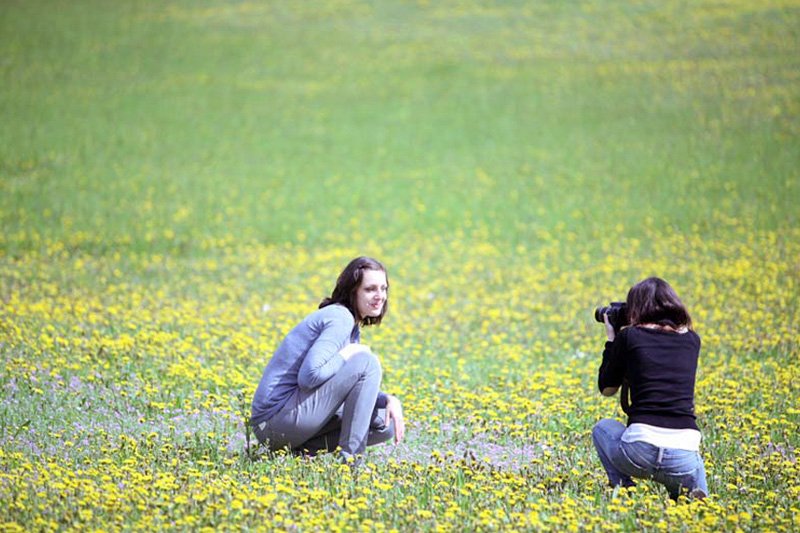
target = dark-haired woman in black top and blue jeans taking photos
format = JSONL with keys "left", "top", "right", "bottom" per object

{"left": 592, "top": 277, "right": 708, "bottom": 499}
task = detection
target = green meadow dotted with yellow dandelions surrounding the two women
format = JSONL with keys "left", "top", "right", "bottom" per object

{"left": 0, "top": 0, "right": 800, "bottom": 531}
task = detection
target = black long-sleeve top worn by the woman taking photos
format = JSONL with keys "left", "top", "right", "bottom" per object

{"left": 597, "top": 327, "right": 700, "bottom": 429}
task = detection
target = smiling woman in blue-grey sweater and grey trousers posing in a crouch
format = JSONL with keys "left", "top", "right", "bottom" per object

{"left": 250, "top": 257, "right": 405, "bottom": 462}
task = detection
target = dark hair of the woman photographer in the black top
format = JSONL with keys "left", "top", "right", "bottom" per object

{"left": 627, "top": 277, "right": 692, "bottom": 329}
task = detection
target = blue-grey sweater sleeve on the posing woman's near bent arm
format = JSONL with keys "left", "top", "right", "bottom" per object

{"left": 297, "top": 310, "right": 354, "bottom": 391}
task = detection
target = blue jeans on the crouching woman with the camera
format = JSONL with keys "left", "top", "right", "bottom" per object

{"left": 592, "top": 418, "right": 708, "bottom": 499}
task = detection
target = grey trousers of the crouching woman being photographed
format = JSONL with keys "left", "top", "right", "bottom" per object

{"left": 253, "top": 352, "right": 394, "bottom": 457}
